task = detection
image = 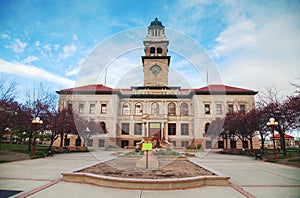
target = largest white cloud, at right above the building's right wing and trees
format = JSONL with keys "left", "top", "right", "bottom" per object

{"left": 213, "top": 13, "right": 300, "bottom": 94}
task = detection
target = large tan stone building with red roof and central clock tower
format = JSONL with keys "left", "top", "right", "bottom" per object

{"left": 57, "top": 18, "right": 257, "bottom": 148}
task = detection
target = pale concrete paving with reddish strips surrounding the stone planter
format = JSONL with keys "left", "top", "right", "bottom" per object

{"left": 0, "top": 150, "right": 300, "bottom": 198}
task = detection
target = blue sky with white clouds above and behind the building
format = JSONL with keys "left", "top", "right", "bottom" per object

{"left": 0, "top": 0, "right": 300, "bottom": 100}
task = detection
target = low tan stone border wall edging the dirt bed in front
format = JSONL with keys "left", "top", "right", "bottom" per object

{"left": 62, "top": 159, "right": 230, "bottom": 190}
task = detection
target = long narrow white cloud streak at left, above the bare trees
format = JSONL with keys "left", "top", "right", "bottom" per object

{"left": 0, "top": 59, "right": 74, "bottom": 87}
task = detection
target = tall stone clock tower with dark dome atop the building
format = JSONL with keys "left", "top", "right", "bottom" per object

{"left": 142, "top": 18, "right": 170, "bottom": 87}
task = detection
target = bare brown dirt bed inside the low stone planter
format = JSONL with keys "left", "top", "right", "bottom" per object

{"left": 78, "top": 158, "right": 215, "bottom": 179}
